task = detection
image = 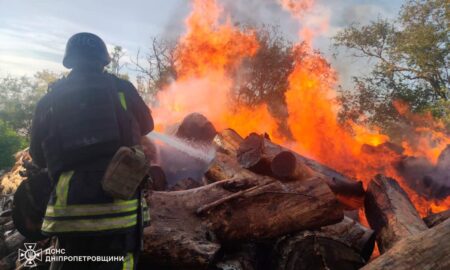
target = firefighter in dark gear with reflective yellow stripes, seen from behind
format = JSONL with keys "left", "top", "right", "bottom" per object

{"left": 30, "top": 33, "right": 153, "bottom": 269}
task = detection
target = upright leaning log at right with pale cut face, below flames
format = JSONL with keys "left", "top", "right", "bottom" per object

{"left": 364, "top": 175, "right": 427, "bottom": 253}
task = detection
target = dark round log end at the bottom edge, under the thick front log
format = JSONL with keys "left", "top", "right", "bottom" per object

{"left": 272, "top": 231, "right": 365, "bottom": 270}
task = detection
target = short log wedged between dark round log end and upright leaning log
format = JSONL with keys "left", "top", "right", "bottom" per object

{"left": 320, "top": 217, "right": 375, "bottom": 261}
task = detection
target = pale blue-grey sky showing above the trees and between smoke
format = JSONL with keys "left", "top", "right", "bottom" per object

{"left": 0, "top": 0, "right": 402, "bottom": 86}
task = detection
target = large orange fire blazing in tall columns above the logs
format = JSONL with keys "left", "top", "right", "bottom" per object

{"left": 154, "top": 0, "right": 450, "bottom": 215}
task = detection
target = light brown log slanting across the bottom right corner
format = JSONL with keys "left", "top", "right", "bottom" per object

{"left": 362, "top": 219, "right": 450, "bottom": 270}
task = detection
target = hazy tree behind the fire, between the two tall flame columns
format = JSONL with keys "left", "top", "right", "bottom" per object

{"left": 232, "top": 25, "right": 302, "bottom": 137}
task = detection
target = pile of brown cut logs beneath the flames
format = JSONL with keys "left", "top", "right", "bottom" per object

{"left": 0, "top": 116, "right": 450, "bottom": 270}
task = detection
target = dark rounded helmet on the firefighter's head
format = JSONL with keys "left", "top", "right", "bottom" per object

{"left": 63, "top": 33, "right": 111, "bottom": 68}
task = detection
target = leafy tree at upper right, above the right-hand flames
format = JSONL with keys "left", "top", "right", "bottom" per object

{"left": 334, "top": 0, "right": 450, "bottom": 131}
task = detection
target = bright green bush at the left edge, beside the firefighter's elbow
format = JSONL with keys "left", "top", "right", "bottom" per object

{"left": 0, "top": 119, "right": 26, "bottom": 170}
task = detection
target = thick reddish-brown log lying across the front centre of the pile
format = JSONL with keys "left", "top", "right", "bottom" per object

{"left": 202, "top": 178, "right": 343, "bottom": 241}
